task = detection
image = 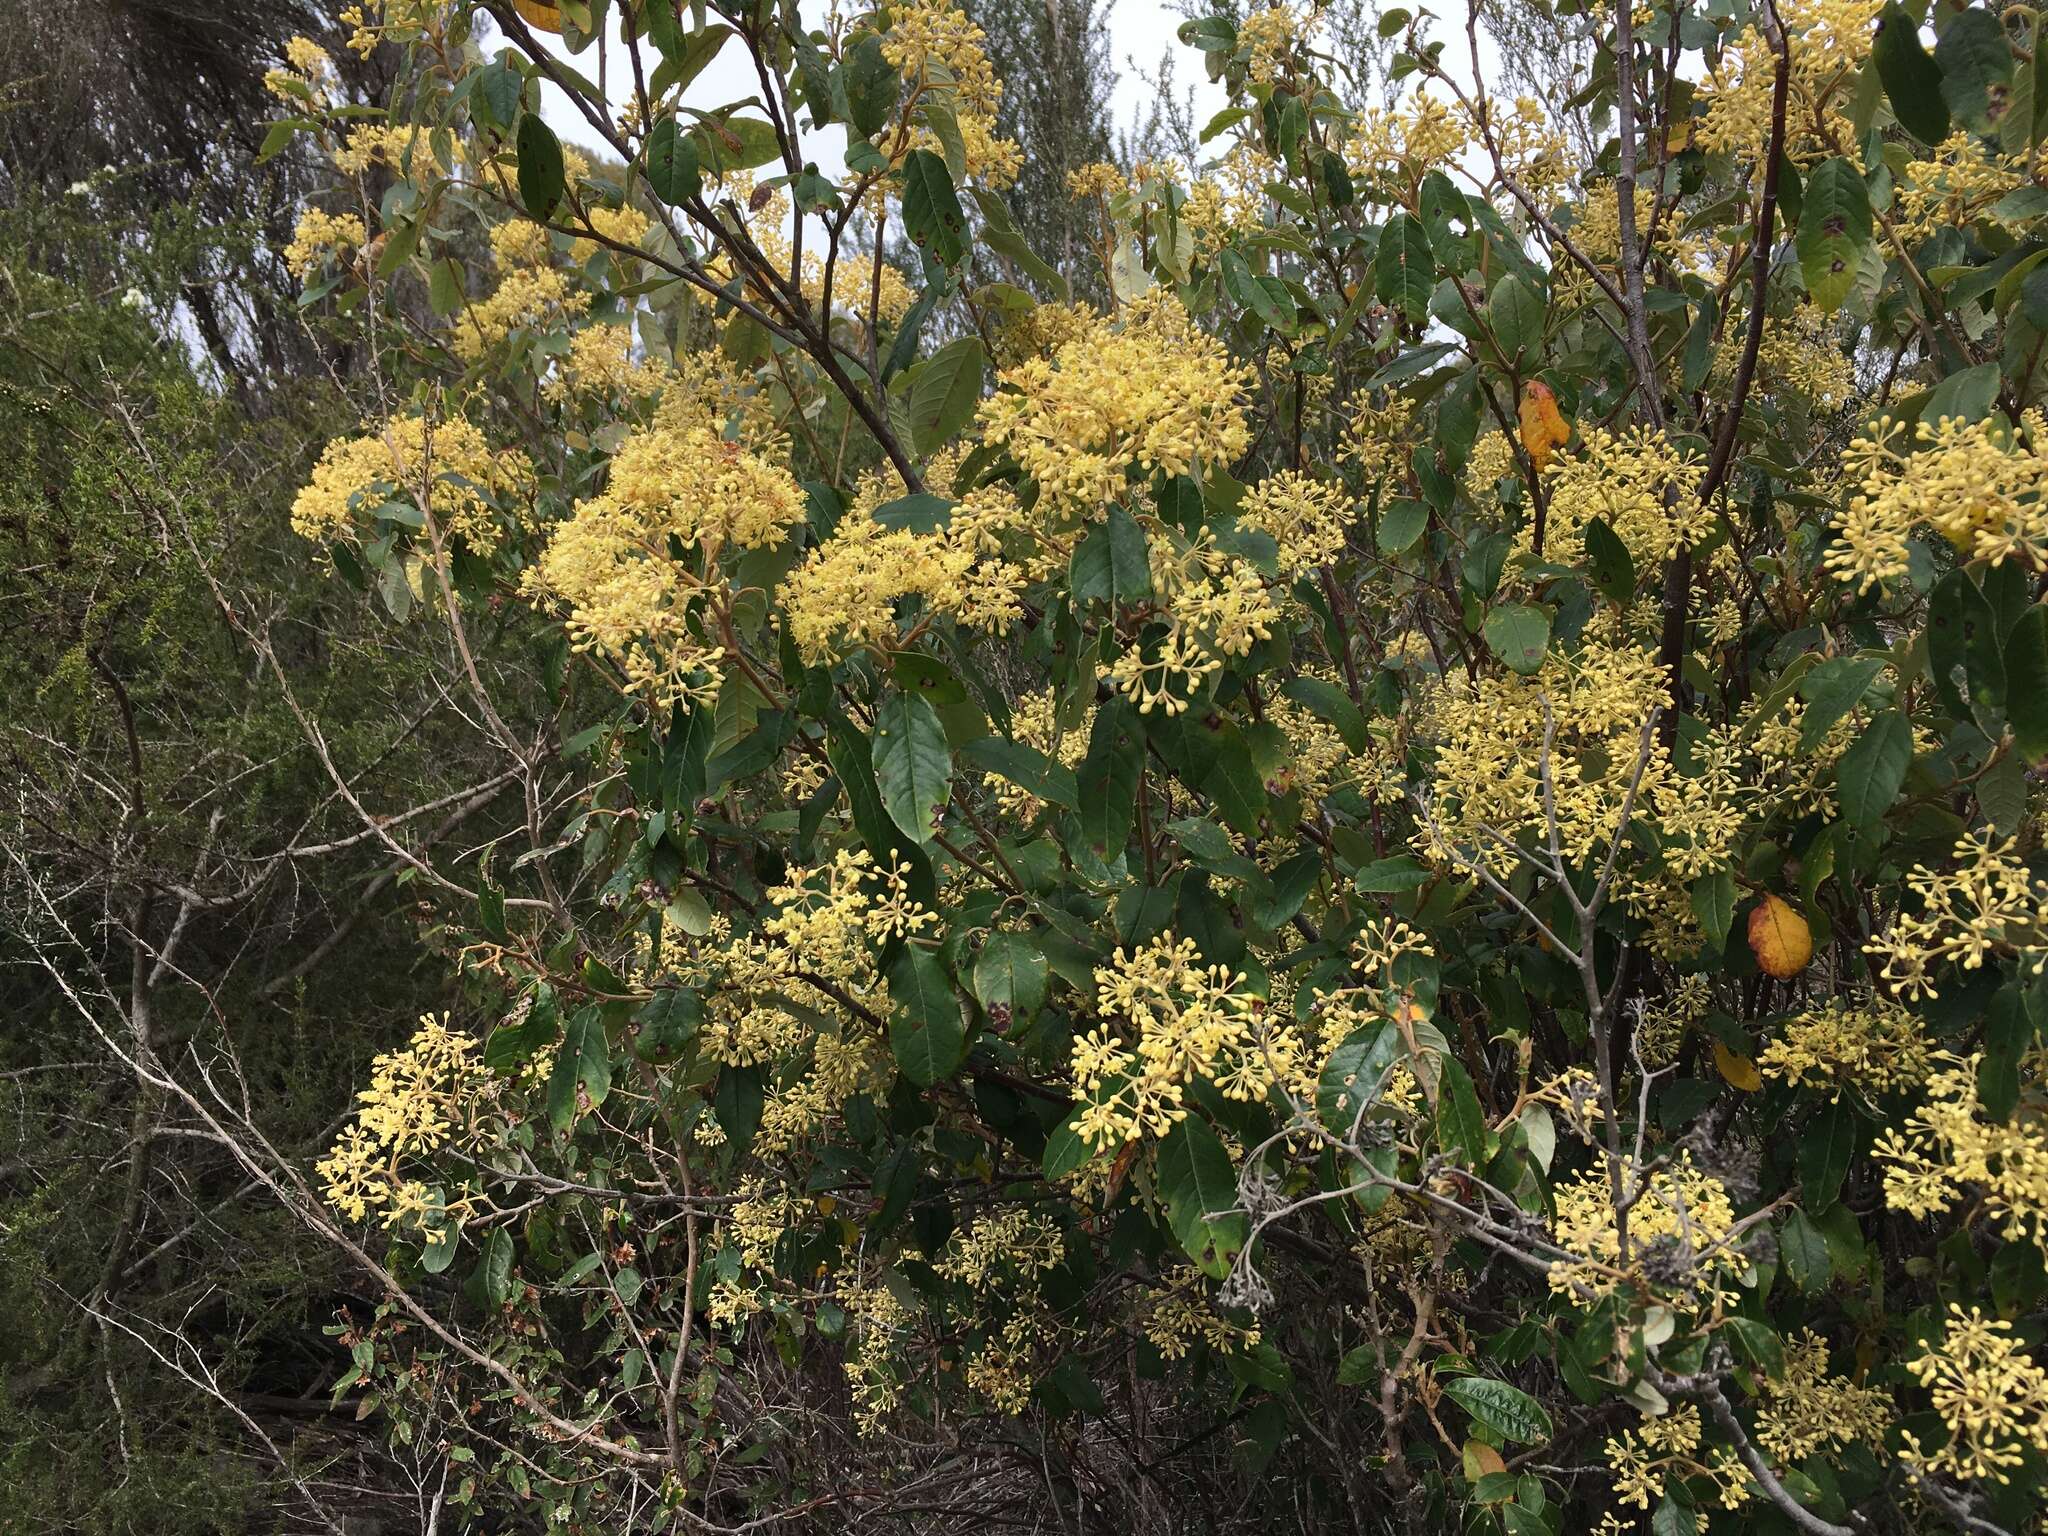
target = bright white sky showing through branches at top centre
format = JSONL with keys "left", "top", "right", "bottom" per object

{"left": 541, "top": 0, "right": 1223, "bottom": 174}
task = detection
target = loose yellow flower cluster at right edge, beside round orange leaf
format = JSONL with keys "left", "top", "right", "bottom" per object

{"left": 1864, "top": 829, "right": 2048, "bottom": 1001}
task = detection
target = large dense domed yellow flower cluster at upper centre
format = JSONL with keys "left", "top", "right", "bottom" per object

{"left": 981, "top": 291, "right": 1251, "bottom": 520}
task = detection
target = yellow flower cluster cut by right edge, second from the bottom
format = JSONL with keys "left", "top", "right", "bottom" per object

{"left": 1872, "top": 1051, "right": 2048, "bottom": 1253}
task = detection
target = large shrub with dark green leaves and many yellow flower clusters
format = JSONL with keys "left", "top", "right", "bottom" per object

{"left": 272, "top": 0, "right": 2048, "bottom": 1534}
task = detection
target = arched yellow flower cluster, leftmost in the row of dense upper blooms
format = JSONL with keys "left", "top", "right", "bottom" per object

{"left": 291, "top": 416, "right": 532, "bottom": 555}
